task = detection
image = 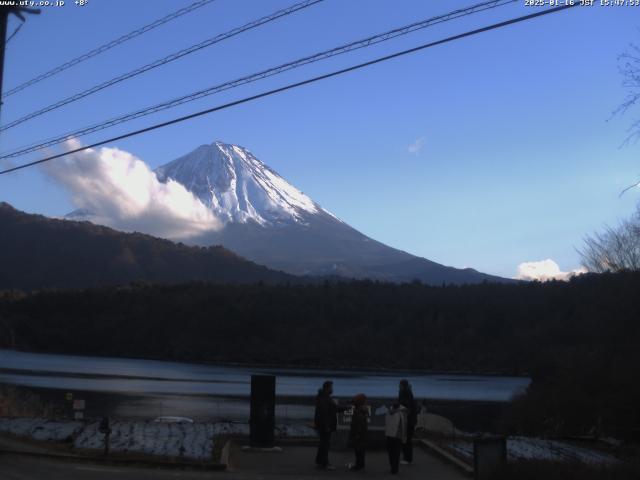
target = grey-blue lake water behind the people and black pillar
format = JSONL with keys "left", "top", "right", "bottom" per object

{"left": 0, "top": 350, "right": 530, "bottom": 418}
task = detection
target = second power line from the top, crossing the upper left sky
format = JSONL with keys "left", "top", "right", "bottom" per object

{"left": 0, "top": 0, "right": 324, "bottom": 132}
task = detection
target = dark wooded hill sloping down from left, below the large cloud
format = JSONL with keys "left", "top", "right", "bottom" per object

{"left": 0, "top": 202, "right": 299, "bottom": 290}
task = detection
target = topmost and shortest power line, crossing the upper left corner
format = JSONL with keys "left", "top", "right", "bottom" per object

{"left": 2, "top": 0, "right": 215, "bottom": 98}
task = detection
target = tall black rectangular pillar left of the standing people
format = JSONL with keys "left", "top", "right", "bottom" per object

{"left": 249, "top": 375, "right": 276, "bottom": 448}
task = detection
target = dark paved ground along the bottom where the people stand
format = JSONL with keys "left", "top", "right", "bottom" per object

{"left": 0, "top": 447, "right": 469, "bottom": 480}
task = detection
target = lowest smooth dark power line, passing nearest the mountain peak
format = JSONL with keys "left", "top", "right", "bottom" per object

{"left": 0, "top": 2, "right": 580, "bottom": 175}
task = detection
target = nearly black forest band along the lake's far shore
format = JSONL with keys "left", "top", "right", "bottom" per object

{"left": 0, "top": 273, "right": 640, "bottom": 374}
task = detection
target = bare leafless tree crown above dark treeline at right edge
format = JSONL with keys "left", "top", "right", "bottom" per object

{"left": 578, "top": 209, "right": 640, "bottom": 273}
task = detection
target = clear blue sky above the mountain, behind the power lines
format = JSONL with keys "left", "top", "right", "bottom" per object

{"left": 0, "top": 0, "right": 640, "bottom": 277}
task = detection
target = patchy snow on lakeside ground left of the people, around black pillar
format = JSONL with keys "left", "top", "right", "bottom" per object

{"left": 0, "top": 418, "right": 315, "bottom": 460}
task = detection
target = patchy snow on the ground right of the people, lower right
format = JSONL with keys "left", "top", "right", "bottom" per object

{"left": 444, "top": 437, "right": 618, "bottom": 464}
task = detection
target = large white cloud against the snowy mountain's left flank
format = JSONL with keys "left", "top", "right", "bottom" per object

{"left": 43, "top": 142, "right": 222, "bottom": 240}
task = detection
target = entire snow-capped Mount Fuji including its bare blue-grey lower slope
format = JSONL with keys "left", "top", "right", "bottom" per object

{"left": 146, "top": 141, "right": 509, "bottom": 285}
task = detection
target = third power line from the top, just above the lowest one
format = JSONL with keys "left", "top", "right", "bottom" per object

{"left": 0, "top": 0, "right": 519, "bottom": 160}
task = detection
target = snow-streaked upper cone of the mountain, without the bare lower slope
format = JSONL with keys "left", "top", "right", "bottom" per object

{"left": 155, "top": 141, "right": 331, "bottom": 225}
